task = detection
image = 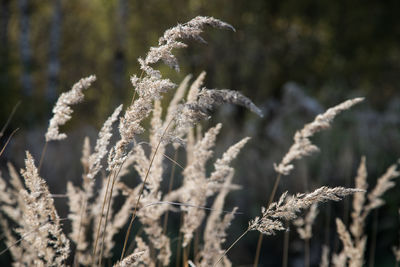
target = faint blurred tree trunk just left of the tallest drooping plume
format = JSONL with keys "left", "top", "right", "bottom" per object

{"left": 114, "top": 0, "right": 129, "bottom": 93}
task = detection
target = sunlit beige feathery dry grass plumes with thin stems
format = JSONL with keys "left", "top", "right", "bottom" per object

{"left": 0, "top": 17, "right": 399, "bottom": 267}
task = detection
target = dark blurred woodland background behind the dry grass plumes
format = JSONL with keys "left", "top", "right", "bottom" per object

{"left": 0, "top": 0, "right": 400, "bottom": 266}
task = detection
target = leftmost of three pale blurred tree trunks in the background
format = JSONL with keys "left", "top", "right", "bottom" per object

{"left": 18, "top": 0, "right": 32, "bottom": 96}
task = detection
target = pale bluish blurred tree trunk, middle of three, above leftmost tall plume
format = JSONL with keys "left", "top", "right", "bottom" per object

{"left": 46, "top": 0, "right": 62, "bottom": 103}
